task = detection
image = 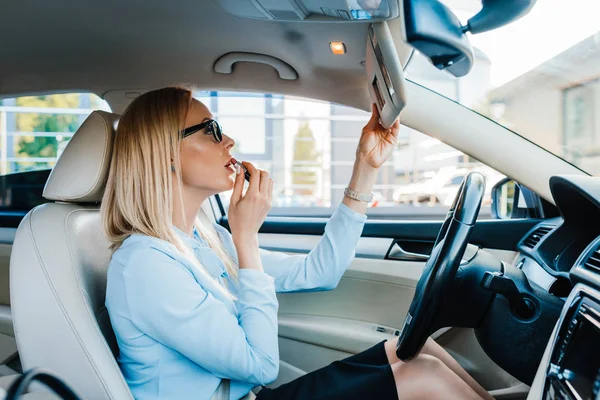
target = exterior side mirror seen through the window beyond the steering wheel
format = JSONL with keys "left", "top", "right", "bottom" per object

{"left": 492, "top": 178, "right": 544, "bottom": 219}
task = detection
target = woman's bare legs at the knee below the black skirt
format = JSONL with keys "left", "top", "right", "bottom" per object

{"left": 391, "top": 353, "right": 481, "bottom": 400}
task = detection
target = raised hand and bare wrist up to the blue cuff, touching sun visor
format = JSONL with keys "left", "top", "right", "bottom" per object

{"left": 343, "top": 104, "right": 400, "bottom": 214}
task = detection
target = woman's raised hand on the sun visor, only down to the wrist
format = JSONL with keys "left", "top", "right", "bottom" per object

{"left": 356, "top": 104, "right": 400, "bottom": 169}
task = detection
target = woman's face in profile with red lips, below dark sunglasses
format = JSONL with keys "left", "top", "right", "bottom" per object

{"left": 180, "top": 99, "right": 235, "bottom": 195}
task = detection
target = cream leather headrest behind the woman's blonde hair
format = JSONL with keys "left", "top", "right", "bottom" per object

{"left": 43, "top": 111, "right": 119, "bottom": 203}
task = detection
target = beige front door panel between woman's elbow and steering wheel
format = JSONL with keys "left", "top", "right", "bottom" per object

{"left": 259, "top": 228, "right": 528, "bottom": 399}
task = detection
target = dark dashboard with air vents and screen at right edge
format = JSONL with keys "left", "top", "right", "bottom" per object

{"left": 516, "top": 176, "right": 600, "bottom": 400}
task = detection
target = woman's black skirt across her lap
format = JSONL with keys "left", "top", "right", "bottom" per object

{"left": 256, "top": 342, "right": 398, "bottom": 400}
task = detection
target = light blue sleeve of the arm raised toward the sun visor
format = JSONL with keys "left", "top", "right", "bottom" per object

{"left": 217, "top": 203, "right": 367, "bottom": 292}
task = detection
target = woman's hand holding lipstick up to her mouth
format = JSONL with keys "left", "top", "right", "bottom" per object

{"left": 227, "top": 161, "right": 273, "bottom": 270}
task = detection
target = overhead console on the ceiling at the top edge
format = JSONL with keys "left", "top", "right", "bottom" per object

{"left": 217, "top": 0, "right": 399, "bottom": 22}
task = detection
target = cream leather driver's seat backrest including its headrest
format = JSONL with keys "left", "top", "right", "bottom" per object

{"left": 10, "top": 111, "right": 133, "bottom": 400}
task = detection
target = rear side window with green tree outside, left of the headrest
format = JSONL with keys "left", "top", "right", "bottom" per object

{"left": 0, "top": 93, "right": 110, "bottom": 220}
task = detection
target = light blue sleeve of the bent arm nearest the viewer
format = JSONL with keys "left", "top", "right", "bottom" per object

{"left": 123, "top": 248, "right": 279, "bottom": 385}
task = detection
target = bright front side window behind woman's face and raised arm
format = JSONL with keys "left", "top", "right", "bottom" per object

{"left": 204, "top": 92, "right": 503, "bottom": 219}
